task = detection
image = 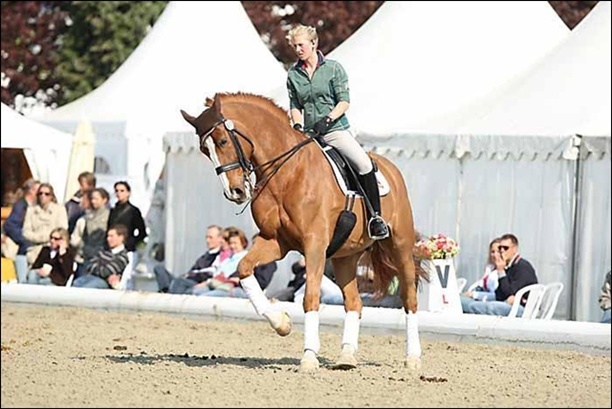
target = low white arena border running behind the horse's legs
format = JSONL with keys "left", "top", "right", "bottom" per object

{"left": 1, "top": 283, "right": 612, "bottom": 354}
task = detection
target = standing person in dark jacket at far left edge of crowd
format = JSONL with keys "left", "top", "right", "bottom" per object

{"left": 2, "top": 179, "right": 39, "bottom": 283}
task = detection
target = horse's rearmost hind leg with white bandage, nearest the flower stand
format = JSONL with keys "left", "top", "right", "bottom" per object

{"left": 389, "top": 234, "right": 421, "bottom": 370}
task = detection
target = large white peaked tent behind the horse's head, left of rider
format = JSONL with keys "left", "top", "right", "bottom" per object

{"left": 37, "top": 1, "right": 286, "bottom": 211}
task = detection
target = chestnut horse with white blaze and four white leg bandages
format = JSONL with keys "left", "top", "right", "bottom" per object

{"left": 181, "top": 93, "right": 421, "bottom": 372}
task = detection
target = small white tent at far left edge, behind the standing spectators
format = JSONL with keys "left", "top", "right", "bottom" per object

{"left": 2, "top": 104, "right": 72, "bottom": 200}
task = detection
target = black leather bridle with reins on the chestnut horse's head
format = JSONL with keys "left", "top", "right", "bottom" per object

{"left": 198, "top": 117, "right": 313, "bottom": 209}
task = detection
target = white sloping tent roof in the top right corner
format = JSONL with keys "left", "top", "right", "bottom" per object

{"left": 432, "top": 2, "right": 612, "bottom": 136}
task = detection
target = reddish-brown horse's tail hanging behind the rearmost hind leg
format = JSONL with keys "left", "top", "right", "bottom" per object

{"left": 370, "top": 241, "right": 429, "bottom": 298}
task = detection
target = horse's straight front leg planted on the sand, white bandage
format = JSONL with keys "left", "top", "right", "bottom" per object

{"left": 299, "top": 242, "right": 325, "bottom": 372}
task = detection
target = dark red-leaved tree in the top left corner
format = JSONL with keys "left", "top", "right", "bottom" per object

{"left": 1, "top": 1, "right": 66, "bottom": 110}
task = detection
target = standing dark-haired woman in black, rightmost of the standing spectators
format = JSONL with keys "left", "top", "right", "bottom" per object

{"left": 108, "top": 181, "right": 147, "bottom": 252}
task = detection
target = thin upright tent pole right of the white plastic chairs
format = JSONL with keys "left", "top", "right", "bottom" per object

{"left": 569, "top": 135, "right": 582, "bottom": 321}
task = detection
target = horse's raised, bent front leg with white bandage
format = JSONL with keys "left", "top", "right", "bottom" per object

{"left": 238, "top": 236, "right": 291, "bottom": 337}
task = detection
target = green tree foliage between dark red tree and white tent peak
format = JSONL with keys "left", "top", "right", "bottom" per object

{"left": 55, "top": 1, "right": 167, "bottom": 105}
